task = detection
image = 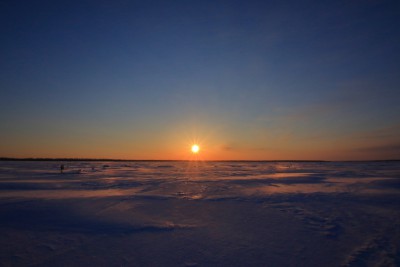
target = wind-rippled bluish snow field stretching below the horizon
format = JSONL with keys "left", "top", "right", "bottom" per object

{"left": 0, "top": 161, "right": 400, "bottom": 266}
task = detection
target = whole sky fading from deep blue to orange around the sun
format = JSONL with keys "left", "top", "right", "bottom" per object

{"left": 0, "top": 0, "right": 400, "bottom": 160}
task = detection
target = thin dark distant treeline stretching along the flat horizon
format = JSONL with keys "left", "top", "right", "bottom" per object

{"left": 0, "top": 157, "right": 400, "bottom": 162}
